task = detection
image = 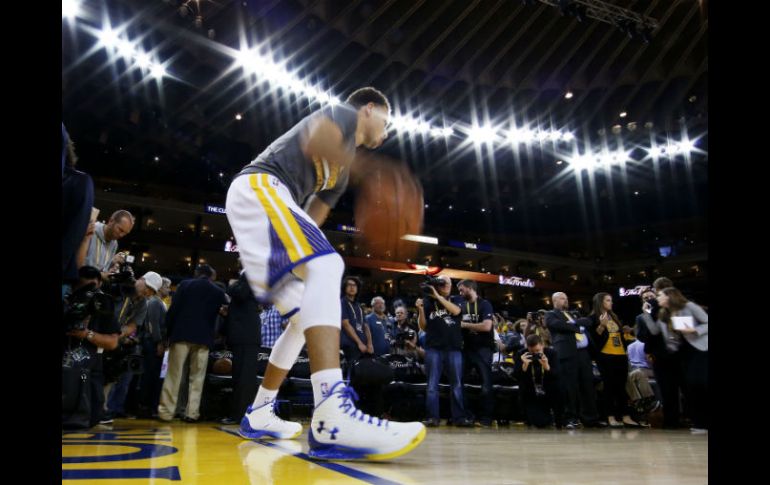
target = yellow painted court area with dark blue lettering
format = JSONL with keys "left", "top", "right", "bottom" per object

{"left": 62, "top": 420, "right": 372, "bottom": 485}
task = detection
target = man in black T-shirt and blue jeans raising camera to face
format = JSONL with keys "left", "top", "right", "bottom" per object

{"left": 415, "top": 275, "right": 473, "bottom": 427}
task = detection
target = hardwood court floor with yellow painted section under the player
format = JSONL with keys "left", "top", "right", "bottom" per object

{"left": 62, "top": 420, "right": 708, "bottom": 485}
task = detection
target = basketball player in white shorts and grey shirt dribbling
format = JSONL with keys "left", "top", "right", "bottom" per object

{"left": 222, "top": 87, "right": 425, "bottom": 460}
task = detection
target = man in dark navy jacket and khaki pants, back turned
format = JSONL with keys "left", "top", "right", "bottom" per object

{"left": 158, "top": 264, "right": 227, "bottom": 422}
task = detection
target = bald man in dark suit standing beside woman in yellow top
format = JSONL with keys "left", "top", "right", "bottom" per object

{"left": 545, "top": 292, "right": 606, "bottom": 429}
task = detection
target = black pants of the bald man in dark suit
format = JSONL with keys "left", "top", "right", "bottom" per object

{"left": 559, "top": 349, "right": 599, "bottom": 423}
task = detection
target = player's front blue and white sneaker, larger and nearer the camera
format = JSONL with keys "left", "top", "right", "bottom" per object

{"left": 308, "top": 381, "right": 426, "bottom": 460}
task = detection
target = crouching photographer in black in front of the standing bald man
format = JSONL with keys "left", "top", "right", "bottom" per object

{"left": 513, "top": 335, "right": 562, "bottom": 428}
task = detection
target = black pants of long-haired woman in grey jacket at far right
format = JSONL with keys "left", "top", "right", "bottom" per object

{"left": 679, "top": 342, "right": 709, "bottom": 429}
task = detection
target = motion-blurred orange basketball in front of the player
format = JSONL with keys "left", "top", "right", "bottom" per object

{"left": 354, "top": 154, "right": 424, "bottom": 261}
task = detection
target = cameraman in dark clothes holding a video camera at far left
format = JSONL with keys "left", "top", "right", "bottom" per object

{"left": 62, "top": 266, "right": 120, "bottom": 428}
